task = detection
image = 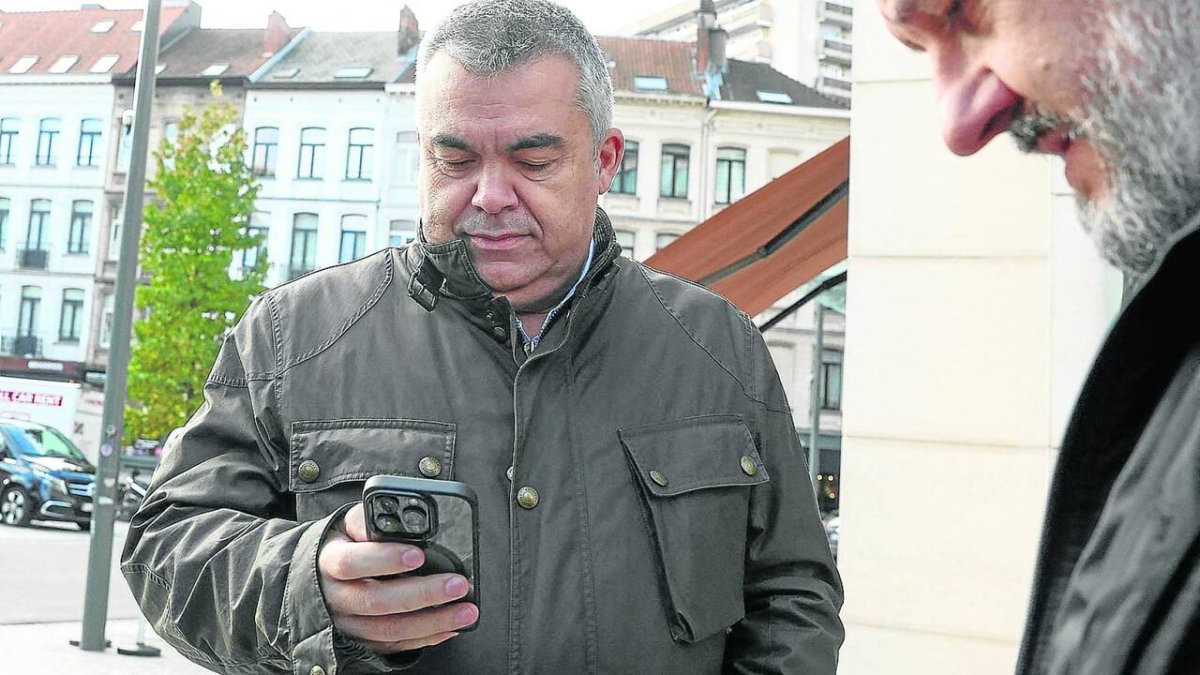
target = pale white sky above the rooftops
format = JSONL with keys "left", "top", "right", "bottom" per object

{"left": 0, "top": 0, "right": 700, "bottom": 35}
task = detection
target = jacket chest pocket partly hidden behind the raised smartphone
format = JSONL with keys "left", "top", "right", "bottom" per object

{"left": 288, "top": 419, "right": 455, "bottom": 521}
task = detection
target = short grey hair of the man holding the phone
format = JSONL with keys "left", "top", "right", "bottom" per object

{"left": 416, "top": 0, "right": 613, "bottom": 153}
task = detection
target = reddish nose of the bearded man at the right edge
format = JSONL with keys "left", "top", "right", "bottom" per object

{"left": 937, "top": 59, "right": 1021, "bottom": 156}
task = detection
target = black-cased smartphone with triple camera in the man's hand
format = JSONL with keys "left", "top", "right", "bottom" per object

{"left": 362, "top": 476, "right": 479, "bottom": 614}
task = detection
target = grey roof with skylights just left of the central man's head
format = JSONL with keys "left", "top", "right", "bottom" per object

{"left": 258, "top": 30, "right": 408, "bottom": 89}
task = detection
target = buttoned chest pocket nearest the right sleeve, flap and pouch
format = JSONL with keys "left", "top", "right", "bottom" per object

{"left": 618, "top": 414, "right": 769, "bottom": 643}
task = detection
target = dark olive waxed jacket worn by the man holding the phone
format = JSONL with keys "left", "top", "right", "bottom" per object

{"left": 122, "top": 210, "right": 844, "bottom": 675}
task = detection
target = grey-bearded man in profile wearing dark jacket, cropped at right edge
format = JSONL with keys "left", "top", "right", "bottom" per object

{"left": 878, "top": 0, "right": 1200, "bottom": 675}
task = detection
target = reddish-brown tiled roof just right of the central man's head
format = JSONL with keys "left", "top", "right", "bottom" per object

{"left": 596, "top": 37, "right": 704, "bottom": 96}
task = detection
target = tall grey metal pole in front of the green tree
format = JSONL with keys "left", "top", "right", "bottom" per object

{"left": 79, "top": 0, "right": 162, "bottom": 651}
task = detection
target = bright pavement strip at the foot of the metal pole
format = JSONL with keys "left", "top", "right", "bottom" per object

{"left": 0, "top": 619, "right": 209, "bottom": 675}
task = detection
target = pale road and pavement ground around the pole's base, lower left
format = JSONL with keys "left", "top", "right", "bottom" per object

{"left": 0, "top": 514, "right": 208, "bottom": 675}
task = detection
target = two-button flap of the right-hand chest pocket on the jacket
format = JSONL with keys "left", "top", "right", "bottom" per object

{"left": 617, "top": 414, "right": 770, "bottom": 497}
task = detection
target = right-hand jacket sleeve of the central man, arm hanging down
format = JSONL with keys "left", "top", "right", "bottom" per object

{"left": 724, "top": 319, "right": 845, "bottom": 675}
